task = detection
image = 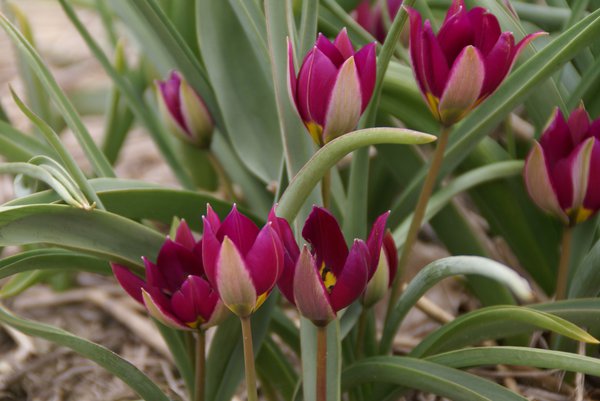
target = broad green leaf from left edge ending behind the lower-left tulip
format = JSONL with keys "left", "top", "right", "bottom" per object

{"left": 0, "top": 205, "right": 164, "bottom": 266}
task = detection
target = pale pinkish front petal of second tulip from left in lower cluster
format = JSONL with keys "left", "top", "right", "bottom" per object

{"left": 216, "top": 237, "right": 257, "bottom": 317}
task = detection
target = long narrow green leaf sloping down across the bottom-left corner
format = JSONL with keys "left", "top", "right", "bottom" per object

{"left": 0, "top": 307, "right": 169, "bottom": 401}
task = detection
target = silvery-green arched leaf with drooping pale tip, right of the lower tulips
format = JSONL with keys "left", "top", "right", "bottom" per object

{"left": 380, "top": 256, "right": 531, "bottom": 353}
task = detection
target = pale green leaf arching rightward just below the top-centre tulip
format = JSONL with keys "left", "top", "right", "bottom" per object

{"left": 277, "top": 128, "right": 435, "bottom": 221}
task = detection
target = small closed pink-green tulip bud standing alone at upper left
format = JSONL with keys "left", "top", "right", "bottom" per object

{"left": 156, "top": 71, "right": 214, "bottom": 149}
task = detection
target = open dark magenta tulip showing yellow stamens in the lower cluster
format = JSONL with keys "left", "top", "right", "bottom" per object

{"left": 279, "top": 206, "right": 388, "bottom": 326}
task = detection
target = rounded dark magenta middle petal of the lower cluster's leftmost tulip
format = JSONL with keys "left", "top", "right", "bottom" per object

{"left": 171, "top": 275, "right": 219, "bottom": 328}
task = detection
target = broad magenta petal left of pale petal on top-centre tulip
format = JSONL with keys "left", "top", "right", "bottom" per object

{"left": 297, "top": 45, "right": 337, "bottom": 126}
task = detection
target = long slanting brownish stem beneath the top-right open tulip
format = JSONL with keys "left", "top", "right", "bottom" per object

{"left": 387, "top": 127, "right": 450, "bottom": 316}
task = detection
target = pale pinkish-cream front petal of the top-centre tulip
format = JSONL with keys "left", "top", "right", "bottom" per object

{"left": 323, "top": 57, "right": 362, "bottom": 143}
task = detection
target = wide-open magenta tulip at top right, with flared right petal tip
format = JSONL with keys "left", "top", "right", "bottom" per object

{"left": 407, "top": 0, "right": 545, "bottom": 127}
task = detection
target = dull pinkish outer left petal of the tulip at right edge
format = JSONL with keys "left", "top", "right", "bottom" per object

{"left": 523, "top": 142, "right": 569, "bottom": 223}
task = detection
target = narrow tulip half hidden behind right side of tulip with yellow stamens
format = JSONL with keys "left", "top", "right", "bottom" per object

{"left": 361, "top": 230, "right": 398, "bottom": 308}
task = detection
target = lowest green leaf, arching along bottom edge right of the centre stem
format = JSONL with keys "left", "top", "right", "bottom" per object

{"left": 342, "top": 356, "right": 526, "bottom": 401}
